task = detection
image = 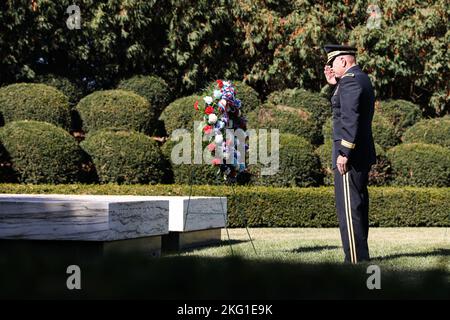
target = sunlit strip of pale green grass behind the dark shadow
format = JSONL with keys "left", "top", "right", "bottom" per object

{"left": 177, "top": 228, "right": 450, "bottom": 272}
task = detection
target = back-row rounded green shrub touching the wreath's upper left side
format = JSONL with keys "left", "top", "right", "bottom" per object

{"left": 160, "top": 95, "right": 203, "bottom": 135}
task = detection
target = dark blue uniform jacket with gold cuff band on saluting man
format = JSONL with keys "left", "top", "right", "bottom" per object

{"left": 331, "top": 65, "right": 376, "bottom": 171}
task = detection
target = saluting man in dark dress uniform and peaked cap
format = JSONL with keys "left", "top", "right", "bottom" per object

{"left": 324, "top": 45, "right": 375, "bottom": 263}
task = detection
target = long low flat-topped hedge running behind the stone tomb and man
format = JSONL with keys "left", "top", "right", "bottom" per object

{"left": 0, "top": 184, "right": 450, "bottom": 227}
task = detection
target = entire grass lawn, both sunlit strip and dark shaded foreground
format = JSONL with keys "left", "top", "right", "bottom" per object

{"left": 0, "top": 228, "right": 450, "bottom": 300}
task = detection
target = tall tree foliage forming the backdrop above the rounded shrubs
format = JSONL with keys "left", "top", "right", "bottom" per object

{"left": 0, "top": 0, "right": 450, "bottom": 114}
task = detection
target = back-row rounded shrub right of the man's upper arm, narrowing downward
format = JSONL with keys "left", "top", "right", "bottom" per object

{"left": 377, "top": 100, "right": 422, "bottom": 134}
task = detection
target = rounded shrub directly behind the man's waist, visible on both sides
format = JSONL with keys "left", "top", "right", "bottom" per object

{"left": 315, "top": 140, "right": 392, "bottom": 186}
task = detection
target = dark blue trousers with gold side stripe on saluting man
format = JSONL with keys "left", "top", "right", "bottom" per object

{"left": 334, "top": 166, "right": 369, "bottom": 263}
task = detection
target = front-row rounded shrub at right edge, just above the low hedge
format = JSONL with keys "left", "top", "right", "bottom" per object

{"left": 387, "top": 143, "right": 450, "bottom": 187}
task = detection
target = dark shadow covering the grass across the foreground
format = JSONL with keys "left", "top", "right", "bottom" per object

{"left": 0, "top": 252, "right": 450, "bottom": 300}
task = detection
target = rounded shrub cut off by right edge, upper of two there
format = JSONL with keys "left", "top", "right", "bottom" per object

{"left": 402, "top": 116, "right": 450, "bottom": 148}
